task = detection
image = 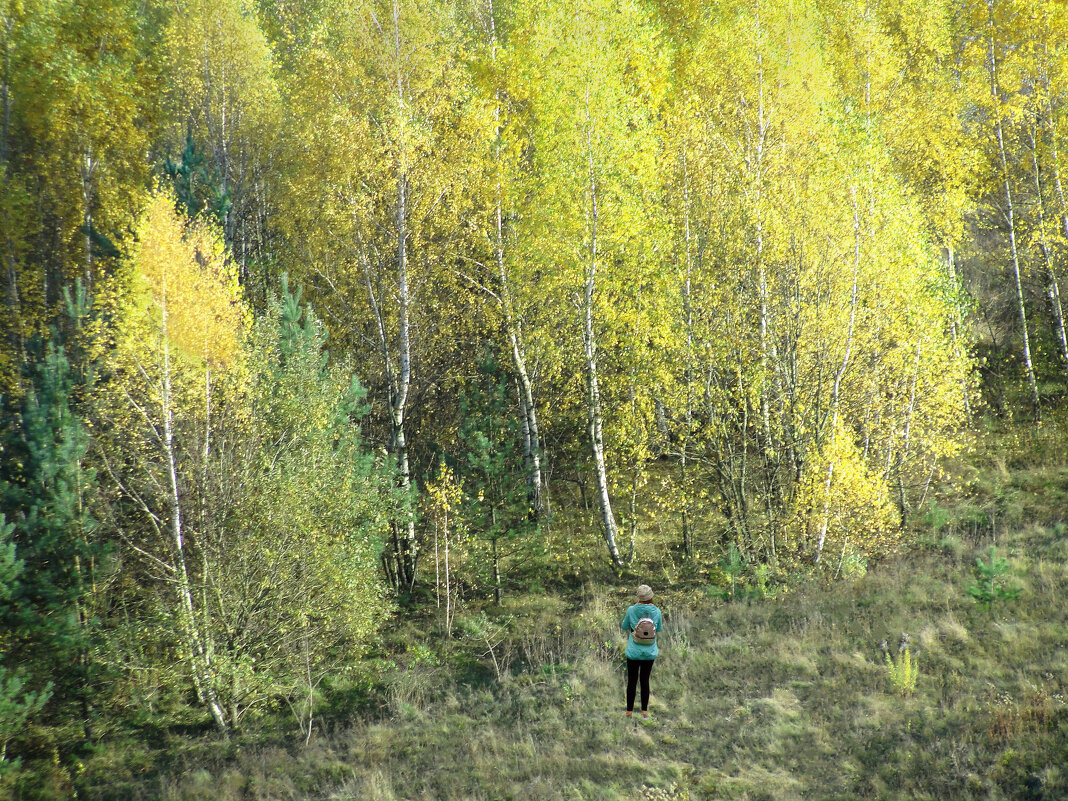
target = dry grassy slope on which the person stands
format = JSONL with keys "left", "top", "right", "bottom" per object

{"left": 121, "top": 426, "right": 1068, "bottom": 800}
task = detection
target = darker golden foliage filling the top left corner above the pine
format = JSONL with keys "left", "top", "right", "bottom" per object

{"left": 0, "top": 0, "right": 153, "bottom": 392}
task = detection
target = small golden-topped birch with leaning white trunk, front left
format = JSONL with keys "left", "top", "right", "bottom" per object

{"left": 93, "top": 194, "right": 242, "bottom": 734}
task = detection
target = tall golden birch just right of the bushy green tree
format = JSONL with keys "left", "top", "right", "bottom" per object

{"left": 281, "top": 0, "right": 474, "bottom": 592}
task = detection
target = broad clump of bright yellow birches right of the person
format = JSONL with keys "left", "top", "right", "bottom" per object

{"left": 661, "top": 2, "right": 969, "bottom": 572}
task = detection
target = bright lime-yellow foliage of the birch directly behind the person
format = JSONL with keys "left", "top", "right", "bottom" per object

{"left": 505, "top": 0, "right": 673, "bottom": 469}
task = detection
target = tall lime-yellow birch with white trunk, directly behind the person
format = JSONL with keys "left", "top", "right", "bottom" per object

{"left": 515, "top": 2, "right": 662, "bottom": 566}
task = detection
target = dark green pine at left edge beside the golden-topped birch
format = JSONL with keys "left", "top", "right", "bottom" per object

{"left": 0, "top": 333, "right": 101, "bottom": 736}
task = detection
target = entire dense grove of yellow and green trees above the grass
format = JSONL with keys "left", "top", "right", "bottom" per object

{"left": 0, "top": 0, "right": 1068, "bottom": 761}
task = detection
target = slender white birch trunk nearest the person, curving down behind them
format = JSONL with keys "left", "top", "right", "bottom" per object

{"left": 582, "top": 82, "right": 624, "bottom": 567}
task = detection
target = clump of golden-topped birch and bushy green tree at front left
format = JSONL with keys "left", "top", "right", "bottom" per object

{"left": 98, "top": 201, "right": 390, "bottom": 725}
